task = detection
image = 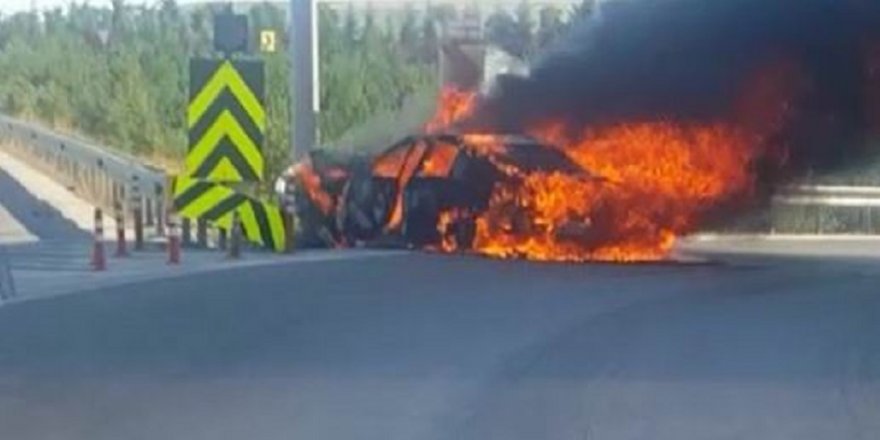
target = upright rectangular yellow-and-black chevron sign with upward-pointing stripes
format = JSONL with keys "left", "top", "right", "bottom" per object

{"left": 186, "top": 58, "right": 266, "bottom": 182}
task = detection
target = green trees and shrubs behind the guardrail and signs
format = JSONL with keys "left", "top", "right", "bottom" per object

{"left": 0, "top": 0, "right": 591, "bottom": 179}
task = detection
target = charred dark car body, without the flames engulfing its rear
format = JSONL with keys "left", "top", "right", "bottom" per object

{"left": 277, "top": 134, "right": 602, "bottom": 251}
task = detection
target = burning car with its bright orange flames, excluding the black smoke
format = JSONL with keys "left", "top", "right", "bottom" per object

{"left": 278, "top": 86, "right": 758, "bottom": 262}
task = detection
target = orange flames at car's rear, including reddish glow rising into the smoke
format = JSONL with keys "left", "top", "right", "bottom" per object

{"left": 430, "top": 63, "right": 799, "bottom": 262}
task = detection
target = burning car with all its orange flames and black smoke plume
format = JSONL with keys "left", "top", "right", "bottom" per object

{"left": 283, "top": 0, "right": 880, "bottom": 262}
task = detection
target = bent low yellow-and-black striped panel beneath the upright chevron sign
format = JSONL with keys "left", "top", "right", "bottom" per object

{"left": 173, "top": 177, "right": 287, "bottom": 252}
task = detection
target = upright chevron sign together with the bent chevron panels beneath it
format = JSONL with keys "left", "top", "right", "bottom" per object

{"left": 173, "top": 51, "right": 287, "bottom": 252}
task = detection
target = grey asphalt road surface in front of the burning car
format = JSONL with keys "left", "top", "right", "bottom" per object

{"left": 0, "top": 249, "right": 880, "bottom": 440}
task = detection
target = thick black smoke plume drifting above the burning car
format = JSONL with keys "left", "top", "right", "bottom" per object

{"left": 471, "top": 0, "right": 880, "bottom": 173}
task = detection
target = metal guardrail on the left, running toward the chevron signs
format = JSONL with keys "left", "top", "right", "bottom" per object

{"left": 0, "top": 115, "right": 168, "bottom": 235}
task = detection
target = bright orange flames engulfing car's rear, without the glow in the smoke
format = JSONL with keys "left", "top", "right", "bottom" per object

{"left": 450, "top": 123, "right": 753, "bottom": 262}
